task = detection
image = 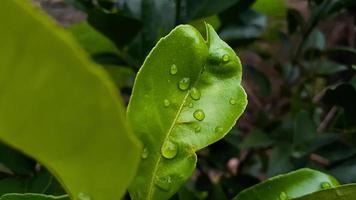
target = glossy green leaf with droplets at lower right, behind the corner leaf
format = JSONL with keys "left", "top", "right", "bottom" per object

{"left": 234, "top": 169, "right": 339, "bottom": 200}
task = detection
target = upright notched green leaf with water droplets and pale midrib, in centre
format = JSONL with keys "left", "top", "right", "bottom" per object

{"left": 128, "top": 25, "right": 247, "bottom": 199}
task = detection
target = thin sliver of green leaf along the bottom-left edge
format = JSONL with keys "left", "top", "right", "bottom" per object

{"left": 0, "top": 193, "right": 69, "bottom": 200}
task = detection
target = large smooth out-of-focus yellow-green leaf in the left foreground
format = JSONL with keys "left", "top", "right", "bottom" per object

{"left": 0, "top": 0, "right": 139, "bottom": 200}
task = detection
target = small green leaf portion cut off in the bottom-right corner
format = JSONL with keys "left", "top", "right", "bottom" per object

{"left": 293, "top": 184, "right": 356, "bottom": 200}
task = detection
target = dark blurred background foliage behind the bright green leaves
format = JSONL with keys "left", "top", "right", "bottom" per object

{"left": 0, "top": 0, "right": 356, "bottom": 200}
